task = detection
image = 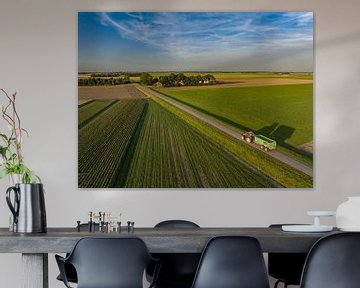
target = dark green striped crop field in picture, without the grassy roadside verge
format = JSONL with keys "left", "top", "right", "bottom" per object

{"left": 79, "top": 99, "right": 276, "bottom": 188}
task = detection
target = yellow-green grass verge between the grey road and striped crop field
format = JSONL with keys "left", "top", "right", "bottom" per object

{"left": 149, "top": 98, "right": 313, "bottom": 188}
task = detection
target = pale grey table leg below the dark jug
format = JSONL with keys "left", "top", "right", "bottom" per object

{"left": 22, "top": 253, "right": 49, "bottom": 288}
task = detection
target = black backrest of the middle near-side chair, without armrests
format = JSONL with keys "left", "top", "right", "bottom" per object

{"left": 192, "top": 236, "right": 269, "bottom": 288}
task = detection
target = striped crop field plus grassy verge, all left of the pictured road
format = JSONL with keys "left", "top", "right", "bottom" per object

{"left": 78, "top": 94, "right": 312, "bottom": 188}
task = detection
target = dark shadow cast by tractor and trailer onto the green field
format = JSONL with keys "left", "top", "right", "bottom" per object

{"left": 256, "top": 122, "right": 313, "bottom": 159}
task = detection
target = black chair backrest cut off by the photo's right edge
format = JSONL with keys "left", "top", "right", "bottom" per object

{"left": 300, "top": 232, "right": 360, "bottom": 288}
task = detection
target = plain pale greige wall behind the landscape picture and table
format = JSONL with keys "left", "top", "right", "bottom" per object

{"left": 0, "top": 0, "right": 360, "bottom": 287}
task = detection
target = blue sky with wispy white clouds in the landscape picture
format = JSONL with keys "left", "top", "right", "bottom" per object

{"left": 78, "top": 12, "right": 313, "bottom": 72}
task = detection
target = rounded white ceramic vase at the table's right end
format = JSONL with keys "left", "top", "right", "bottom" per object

{"left": 336, "top": 196, "right": 360, "bottom": 231}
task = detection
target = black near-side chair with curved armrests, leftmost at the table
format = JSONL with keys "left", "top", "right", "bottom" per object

{"left": 55, "top": 237, "right": 160, "bottom": 288}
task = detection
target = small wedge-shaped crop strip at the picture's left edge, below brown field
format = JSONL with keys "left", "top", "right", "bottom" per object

{"left": 78, "top": 100, "right": 116, "bottom": 128}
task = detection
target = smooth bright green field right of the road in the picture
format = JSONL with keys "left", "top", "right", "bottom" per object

{"left": 160, "top": 84, "right": 313, "bottom": 147}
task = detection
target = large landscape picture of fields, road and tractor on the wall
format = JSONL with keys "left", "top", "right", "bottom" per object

{"left": 78, "top": 12, "right": 314, "bottom": 189}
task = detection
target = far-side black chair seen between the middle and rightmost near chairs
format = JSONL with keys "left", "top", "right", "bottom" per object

{"left": 268, "top": 224, "right": 307, "bottom": 288}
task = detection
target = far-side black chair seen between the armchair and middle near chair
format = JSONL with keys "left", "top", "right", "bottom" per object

{"left": 147, "top": 220, "right": 201, "bottom": 288}
